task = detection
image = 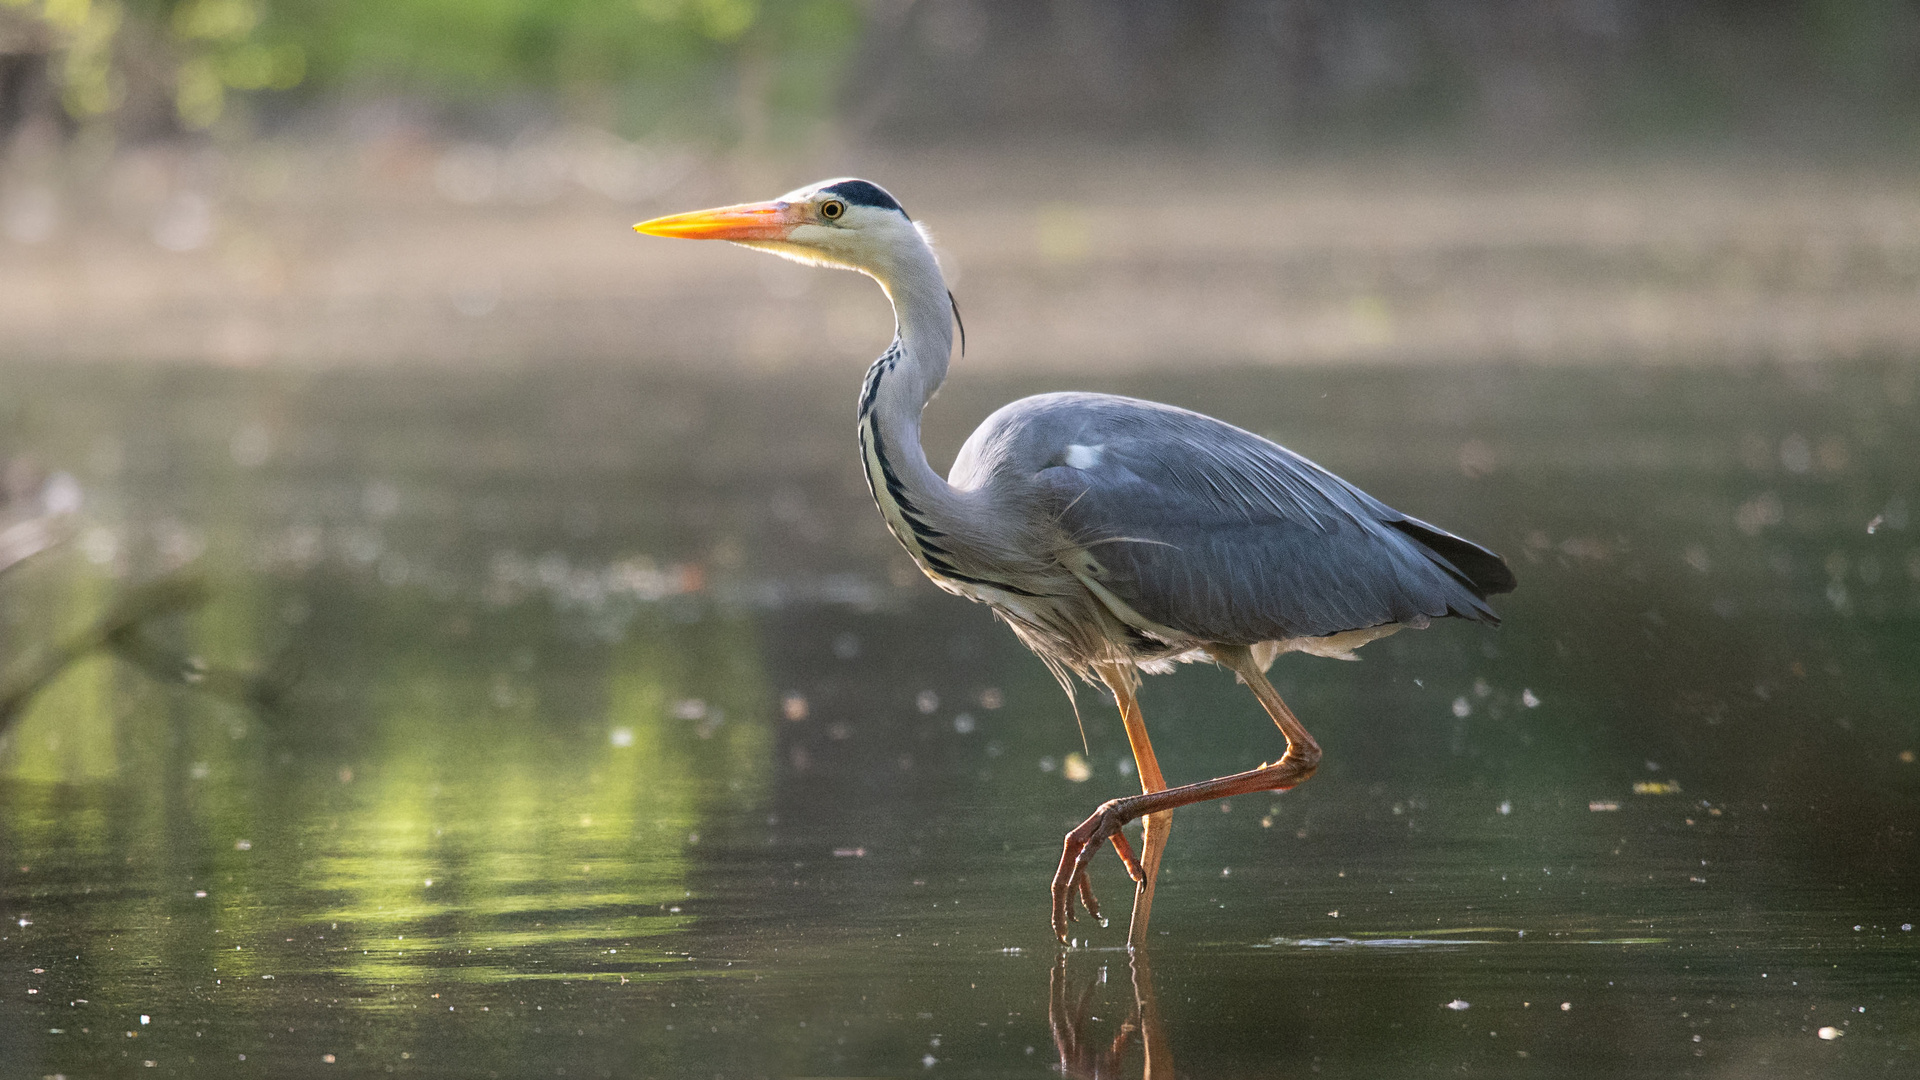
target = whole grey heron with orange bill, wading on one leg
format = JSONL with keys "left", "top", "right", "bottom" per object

{"left": 636, "top": 181, "right": 1513, "bottom": 942}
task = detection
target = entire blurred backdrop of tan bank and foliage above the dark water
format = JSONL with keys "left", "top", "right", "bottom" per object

{"left": 0, "top": 0, "right": 1920, "bottom": 369}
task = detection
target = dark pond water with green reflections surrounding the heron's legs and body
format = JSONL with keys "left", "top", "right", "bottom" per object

{"left": 0, "top": 361, "right": 1920, "bottom": 1078}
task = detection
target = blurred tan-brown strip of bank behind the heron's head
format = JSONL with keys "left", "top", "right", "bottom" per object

{"left": 0, "top": 129, "right": 1920, "bottom": 371}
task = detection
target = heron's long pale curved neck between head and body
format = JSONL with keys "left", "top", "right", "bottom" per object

{"left": 860, "top": 236, "right": 958, "bottom": 530}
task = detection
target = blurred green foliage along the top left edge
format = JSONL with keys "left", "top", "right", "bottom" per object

{"left": 0, "top": 0, "right": 862, "bottom": 129}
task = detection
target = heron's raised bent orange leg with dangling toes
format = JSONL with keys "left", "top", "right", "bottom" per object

{"left": 1054, "top": 646, "right": 1321, "bottom": 942}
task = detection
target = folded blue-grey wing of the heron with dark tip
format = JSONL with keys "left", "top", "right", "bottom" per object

{"left": 990, "top": 394, "right": 1513, "bottom": 644}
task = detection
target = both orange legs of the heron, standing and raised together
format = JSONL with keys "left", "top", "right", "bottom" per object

{"left": 1052, "top": 646, "right": 1321, "bottom": 944}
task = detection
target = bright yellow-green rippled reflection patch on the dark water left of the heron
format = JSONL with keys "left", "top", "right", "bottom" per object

{"left": 301, "top": 621, "right": 768, "bottom": 984}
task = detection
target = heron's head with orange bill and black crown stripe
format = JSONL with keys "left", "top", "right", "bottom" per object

{"left": 634, "top": 179, "right": 925, "bottom": 281}
